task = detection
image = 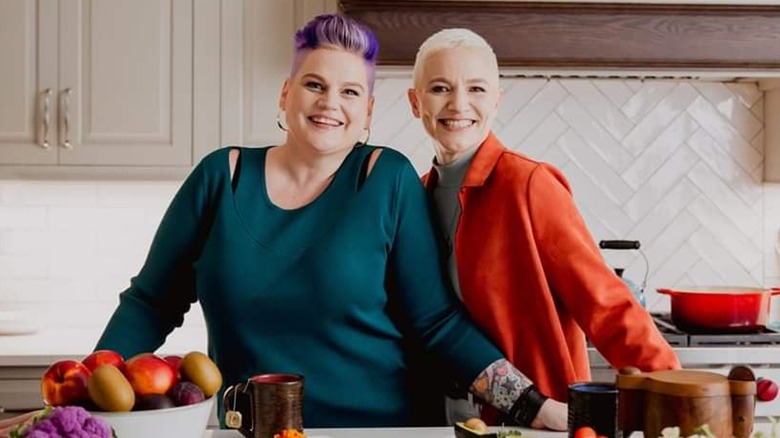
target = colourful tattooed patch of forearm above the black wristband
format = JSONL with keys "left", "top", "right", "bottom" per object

{"left": 469, "top": 359, "right": 532, "bottom": 412}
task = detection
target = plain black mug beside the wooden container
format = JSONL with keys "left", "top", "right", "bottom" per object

{"left": 568, "top": 382, "right": 622, "bottom": 438}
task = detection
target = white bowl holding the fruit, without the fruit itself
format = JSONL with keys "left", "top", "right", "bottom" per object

{"left": 90, "top": 396, "right": 216, "bottom": 438}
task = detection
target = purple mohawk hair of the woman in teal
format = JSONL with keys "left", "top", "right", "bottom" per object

{"left": 290, "top": 14, "right": 379, "bottom": 93}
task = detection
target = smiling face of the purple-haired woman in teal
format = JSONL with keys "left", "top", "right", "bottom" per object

{"left": 279, "top": 47, "right": 374, "bottom": 154}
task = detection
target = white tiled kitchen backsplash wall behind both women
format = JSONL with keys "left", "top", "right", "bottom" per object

{"left": 0, "top": 77, "right": 780, "bottom": 336}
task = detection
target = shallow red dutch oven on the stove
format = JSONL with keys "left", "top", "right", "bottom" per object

{"left": 657, "top": 286, "right": 780, "bottom": 333}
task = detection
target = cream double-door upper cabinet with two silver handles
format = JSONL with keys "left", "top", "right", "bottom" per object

{"left": 0, "top": 0, "right": 194, "bottom": 178}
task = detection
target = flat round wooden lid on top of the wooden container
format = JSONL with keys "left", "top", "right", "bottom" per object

{"left": 645, "top": 370, "right": 731, "bottom": 397}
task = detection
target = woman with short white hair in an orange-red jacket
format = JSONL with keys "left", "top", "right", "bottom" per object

{"left": 408, "top": 29, "right": 680, "bottom": 422}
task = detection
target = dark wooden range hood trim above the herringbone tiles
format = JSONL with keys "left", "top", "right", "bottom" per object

{"left": 338, "top": 0, "right": 780, "bottom": 72}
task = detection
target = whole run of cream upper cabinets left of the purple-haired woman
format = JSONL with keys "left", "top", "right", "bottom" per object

{"left": 0, "top": 0, "right": 337, "bottom": 179}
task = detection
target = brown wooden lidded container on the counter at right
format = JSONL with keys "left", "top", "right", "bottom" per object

{"left": 616, "top": 370, "right": 756, "bottom": 438}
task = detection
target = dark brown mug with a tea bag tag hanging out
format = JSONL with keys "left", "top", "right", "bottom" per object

{"left": 222, "top": 374, "right": 303, "bottom": 438}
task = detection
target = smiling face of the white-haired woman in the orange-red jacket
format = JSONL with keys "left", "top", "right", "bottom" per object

{"left": 408, "top": 47, "right": 501, "bottom": 164}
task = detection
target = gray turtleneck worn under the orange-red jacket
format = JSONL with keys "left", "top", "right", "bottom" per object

{"left": 433, "top": 147, "right": 479, "bottom": 300}
